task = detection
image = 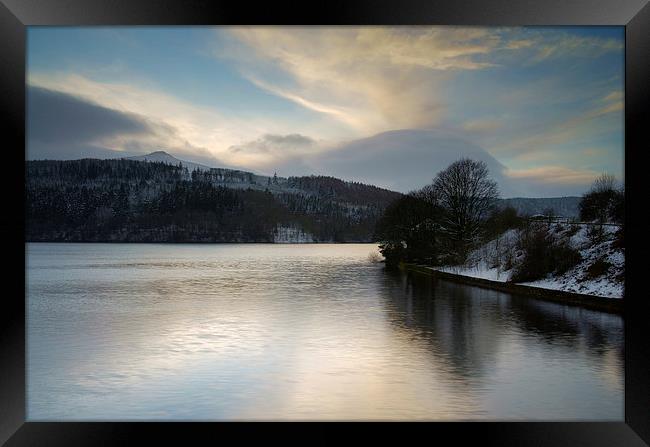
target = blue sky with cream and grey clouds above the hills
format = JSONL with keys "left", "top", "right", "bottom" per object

{"left": 26, "top": 26, "right": 624, "bottom": 197}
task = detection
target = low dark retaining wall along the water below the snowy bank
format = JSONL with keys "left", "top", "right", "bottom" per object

{"left": 399, "top": 263, "right": 623, "bottom": 314}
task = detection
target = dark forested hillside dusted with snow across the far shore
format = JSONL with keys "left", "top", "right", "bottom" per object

{"left": 25, "top": 159, "right": 401, "bottom": 242}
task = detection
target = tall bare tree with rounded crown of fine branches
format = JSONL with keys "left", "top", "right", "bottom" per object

{"left": 433, "top": 158, "right": 499, "bottom": 260}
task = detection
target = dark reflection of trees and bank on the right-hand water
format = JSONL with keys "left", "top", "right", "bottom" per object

{"left": 383, "top": 272, "right": 623, "bottom": 374}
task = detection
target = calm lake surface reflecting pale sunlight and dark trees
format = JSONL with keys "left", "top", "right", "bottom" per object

{"left": 26, "top": 243, "right": 623, "bottom": 421}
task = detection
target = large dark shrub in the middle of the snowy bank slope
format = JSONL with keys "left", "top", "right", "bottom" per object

{"left": 511, "top": 223, "right": 581, "bottom": 282}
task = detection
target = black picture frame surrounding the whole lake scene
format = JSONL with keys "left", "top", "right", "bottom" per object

{"left": 0, "top": 0, "right": 650, "bottom": 446}
